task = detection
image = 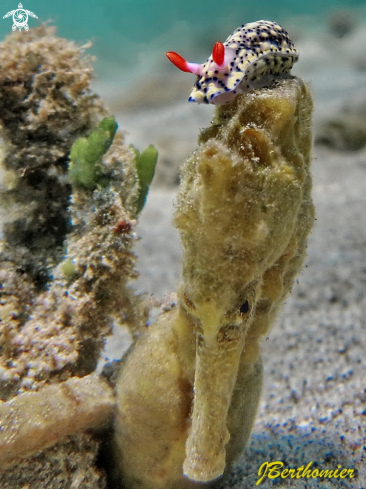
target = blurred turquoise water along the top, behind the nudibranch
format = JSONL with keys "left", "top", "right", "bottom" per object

{"left": 0, "top": 0, "right": 366, "bottom": 84}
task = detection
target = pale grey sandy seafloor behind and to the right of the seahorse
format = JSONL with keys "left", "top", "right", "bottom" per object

{"left": 97, "top": 17, "right": 366, "bottom": 489}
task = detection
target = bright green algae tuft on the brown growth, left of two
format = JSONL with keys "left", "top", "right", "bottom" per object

{"left": 69, "top": 116, "right": 118, "bottom": 190}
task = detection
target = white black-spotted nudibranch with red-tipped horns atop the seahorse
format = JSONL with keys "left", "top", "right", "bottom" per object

{"left": 166, "top": 20, "right": 299, "bottom": 105}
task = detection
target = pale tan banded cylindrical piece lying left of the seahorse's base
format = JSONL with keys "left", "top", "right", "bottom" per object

{"left": 0, "top": 374, "right": 114, "bottom": 469}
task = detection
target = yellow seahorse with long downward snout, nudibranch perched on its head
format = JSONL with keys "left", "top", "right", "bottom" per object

{"left": 115, "top": 78, "right": 314, "bottom": 489}
